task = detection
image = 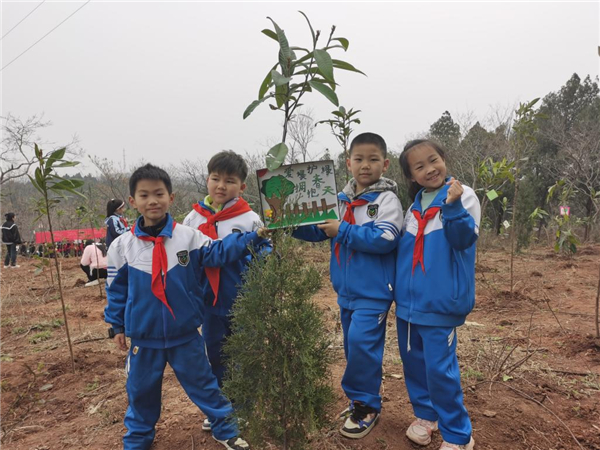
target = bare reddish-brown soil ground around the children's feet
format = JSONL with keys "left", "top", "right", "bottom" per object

{"left": 0, "top": 246, "right": 600, "bottom": 450}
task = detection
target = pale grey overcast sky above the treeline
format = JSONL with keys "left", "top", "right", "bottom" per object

{"left": 0, "top": 0, "right": 599, "bottom": 174}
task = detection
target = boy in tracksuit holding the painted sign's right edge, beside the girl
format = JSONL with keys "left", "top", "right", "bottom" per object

{"left": 293, "top": 133, "right": 402, "bottom": 439}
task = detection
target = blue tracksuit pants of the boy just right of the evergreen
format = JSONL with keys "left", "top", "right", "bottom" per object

{"left": 340, "top": 307, "right": 387, "bottom": 411}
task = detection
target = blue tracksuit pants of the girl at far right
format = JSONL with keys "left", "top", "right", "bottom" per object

{"left": 396, "top": 318, "right": 472, "bottom": 445}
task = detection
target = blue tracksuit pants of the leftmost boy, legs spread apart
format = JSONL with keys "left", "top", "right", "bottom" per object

{"left": 123, "top": 335, "right": 238, "bottom": 450}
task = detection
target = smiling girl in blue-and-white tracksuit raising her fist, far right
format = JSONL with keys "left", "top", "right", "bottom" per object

{"left": 395, "top": 140, "right": 481, "bottom": 450}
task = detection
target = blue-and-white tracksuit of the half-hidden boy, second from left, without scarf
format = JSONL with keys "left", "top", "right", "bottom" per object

{"left": 183, "top": 198, "right": 271, "bottom": 386}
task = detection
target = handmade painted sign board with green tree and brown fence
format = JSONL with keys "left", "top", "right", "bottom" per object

{"left": 256, "top": 160, "right": 340, "bottom": 228}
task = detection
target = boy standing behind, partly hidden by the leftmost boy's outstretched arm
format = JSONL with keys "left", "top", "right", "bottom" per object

{"left": 183, "top": 150, "right": 263, "bottom": 431}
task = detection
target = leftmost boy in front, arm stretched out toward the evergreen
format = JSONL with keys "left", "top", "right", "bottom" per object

{"left": 104, "top": 164, "right": 262, "bottom": 450}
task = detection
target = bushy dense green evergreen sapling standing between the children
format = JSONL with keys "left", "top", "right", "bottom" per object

{"left": 224, "top": 231, "right": 333, "bottom": 449}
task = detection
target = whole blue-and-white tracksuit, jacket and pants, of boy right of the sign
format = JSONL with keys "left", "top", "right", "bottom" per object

{"left": 293, "top": 178, "right": 402, "bottom": 411}
